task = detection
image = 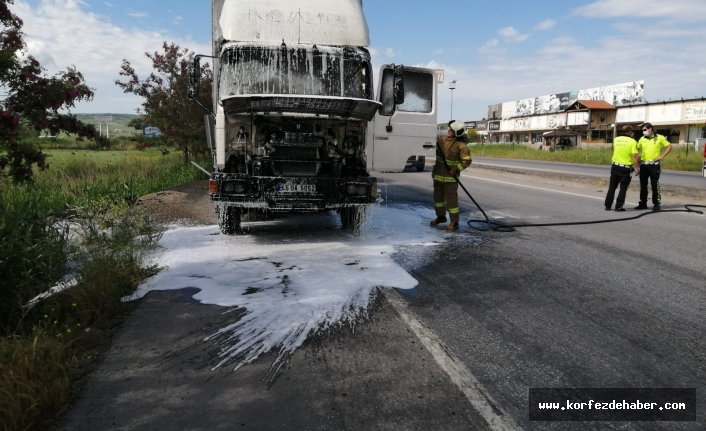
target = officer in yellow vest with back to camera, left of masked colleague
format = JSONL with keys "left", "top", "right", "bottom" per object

{"left": 605, "top": 125, "right": 640, "bottom": 211}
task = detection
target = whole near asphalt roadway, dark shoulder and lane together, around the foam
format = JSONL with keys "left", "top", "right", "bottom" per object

{"left": 59, "top": 169, "right": 706, "bottom": 430}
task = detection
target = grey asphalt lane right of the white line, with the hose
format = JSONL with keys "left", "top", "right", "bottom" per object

{"left": 388, "top": 170, "right": 706, "bottom": 430}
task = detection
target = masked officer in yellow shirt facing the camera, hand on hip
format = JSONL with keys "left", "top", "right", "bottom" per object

{"left": 635, "top": 123, "right": 672, "bottom": 211}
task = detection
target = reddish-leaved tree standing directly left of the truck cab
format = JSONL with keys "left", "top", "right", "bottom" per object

{"left": 115, "top": 42, "right": 213, "bottom": 163}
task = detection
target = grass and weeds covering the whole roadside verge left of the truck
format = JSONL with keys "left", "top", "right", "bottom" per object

{"left": 0, "top": 150, "right": 208, "bottom": 431}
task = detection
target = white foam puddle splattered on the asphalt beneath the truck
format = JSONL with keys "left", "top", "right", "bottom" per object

{"left": 130, "top": 206, "right": 449, "bottom": 372}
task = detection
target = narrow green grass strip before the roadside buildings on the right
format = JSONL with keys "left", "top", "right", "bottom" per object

{"left": 470, "top": 144, "right": 704, "bottom": 172}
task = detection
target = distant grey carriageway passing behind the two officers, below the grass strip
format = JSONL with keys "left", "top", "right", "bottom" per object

{"left": 473, "top": 155, "right": 706, "bottom": 189}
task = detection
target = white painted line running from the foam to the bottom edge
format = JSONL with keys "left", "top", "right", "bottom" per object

{"left": 382, "top": 288, "right": 522, "bottom": 431}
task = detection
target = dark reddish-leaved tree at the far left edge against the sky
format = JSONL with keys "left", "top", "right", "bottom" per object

{"left": 0, "top": 0, "right": 108, "bottom": 183}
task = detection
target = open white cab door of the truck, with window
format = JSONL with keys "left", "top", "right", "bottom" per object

{"left": 368, "top": 65, "right": 443, "bottom": 172}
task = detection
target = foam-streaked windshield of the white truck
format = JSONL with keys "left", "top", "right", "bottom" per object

{"left": 219, "top": 46, "right": 372, "bottom": 100}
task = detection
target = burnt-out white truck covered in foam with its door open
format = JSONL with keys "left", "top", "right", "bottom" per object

{"left": 189, "top": 0, "right": 443, "bottom": 235}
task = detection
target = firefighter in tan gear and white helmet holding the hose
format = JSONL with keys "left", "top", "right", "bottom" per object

{"left": 429, "top": 121, "right": 472, "bottom": 230}
